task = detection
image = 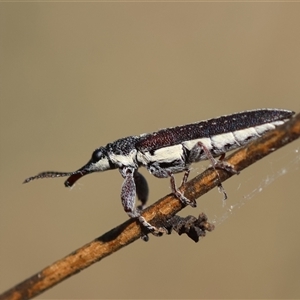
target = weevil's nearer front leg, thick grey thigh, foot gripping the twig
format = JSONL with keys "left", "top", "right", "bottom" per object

{"left": 120, "top": 167, "right": 166, "bottom": 236}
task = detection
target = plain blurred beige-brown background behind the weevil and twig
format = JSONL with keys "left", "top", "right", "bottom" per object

{"left": 0, "top": 3, "right": 300, "bottom": 299}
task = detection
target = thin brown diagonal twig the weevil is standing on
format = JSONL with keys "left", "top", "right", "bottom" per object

{"left": 0, "top": 114, "right": 300, "bottom": 300}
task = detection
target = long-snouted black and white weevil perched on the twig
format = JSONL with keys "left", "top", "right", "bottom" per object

{"left": 24, "top": 109, "right": 294, "bottom": 235}
